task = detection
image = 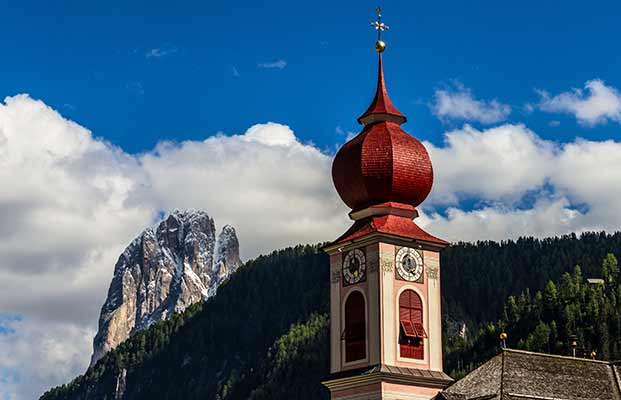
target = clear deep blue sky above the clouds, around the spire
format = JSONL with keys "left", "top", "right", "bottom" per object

{"left": 0, "top": 1, "right": 621, "bottom": 153}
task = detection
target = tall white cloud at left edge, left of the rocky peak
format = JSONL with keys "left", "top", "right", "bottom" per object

{"left": 0, "top": 95, "right": 153, "bottom": 399}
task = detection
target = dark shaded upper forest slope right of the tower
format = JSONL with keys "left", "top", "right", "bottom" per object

{"left": 442, "top": 232, "right": 621, "bottom": 323}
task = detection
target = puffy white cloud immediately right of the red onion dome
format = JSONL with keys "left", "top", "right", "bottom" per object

{"left": 425, "top": 125, "right": 555, "bottom": 205}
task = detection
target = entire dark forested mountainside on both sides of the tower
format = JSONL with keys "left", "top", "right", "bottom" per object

{"left": 43, "top": 233, "right": 621, "bottom": 400}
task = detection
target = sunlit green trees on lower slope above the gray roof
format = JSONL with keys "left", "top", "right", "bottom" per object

{"left": 445, "top": 253, "right": 621, "bottom": 377}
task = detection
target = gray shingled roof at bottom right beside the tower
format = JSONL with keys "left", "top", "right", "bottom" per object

{"left": 437, "top": 349, "right": 621, "bottom": 400}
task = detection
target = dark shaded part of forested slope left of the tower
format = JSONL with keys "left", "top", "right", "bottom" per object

{"left": 43, "top": 246, "right": 329, "bottom": 400}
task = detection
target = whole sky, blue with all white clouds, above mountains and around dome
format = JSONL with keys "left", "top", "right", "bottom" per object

{"left": 0, "top": 0, "right": 621, "bottom": 400}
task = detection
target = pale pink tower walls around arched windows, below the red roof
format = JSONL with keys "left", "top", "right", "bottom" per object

{"left": 330, "top": 238, "right": 442, "bottom": 390}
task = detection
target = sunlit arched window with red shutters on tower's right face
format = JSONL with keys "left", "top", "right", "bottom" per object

{"left": 399, "top": 289, "right": 427, "bottom": 360}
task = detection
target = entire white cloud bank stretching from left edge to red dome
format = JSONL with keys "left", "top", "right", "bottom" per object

{"left": 0, "top": 95, "right": 347, "bottom": 399}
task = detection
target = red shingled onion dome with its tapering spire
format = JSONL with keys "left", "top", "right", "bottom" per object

{"left": 332, "top": 53, "right": 433, "bottom": 213}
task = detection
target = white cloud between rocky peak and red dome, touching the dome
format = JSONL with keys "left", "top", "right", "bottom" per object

{"left": 141, "top": 123, "right": 347, "bottom": 257}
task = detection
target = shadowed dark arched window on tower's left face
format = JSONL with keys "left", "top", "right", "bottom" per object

{"left": 341, "top": 291, "right": 367, "bottom": 362}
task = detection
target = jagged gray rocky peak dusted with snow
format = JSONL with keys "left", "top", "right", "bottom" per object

{"left": 91, "top": 210, "right": 240, "bottom": 365}
